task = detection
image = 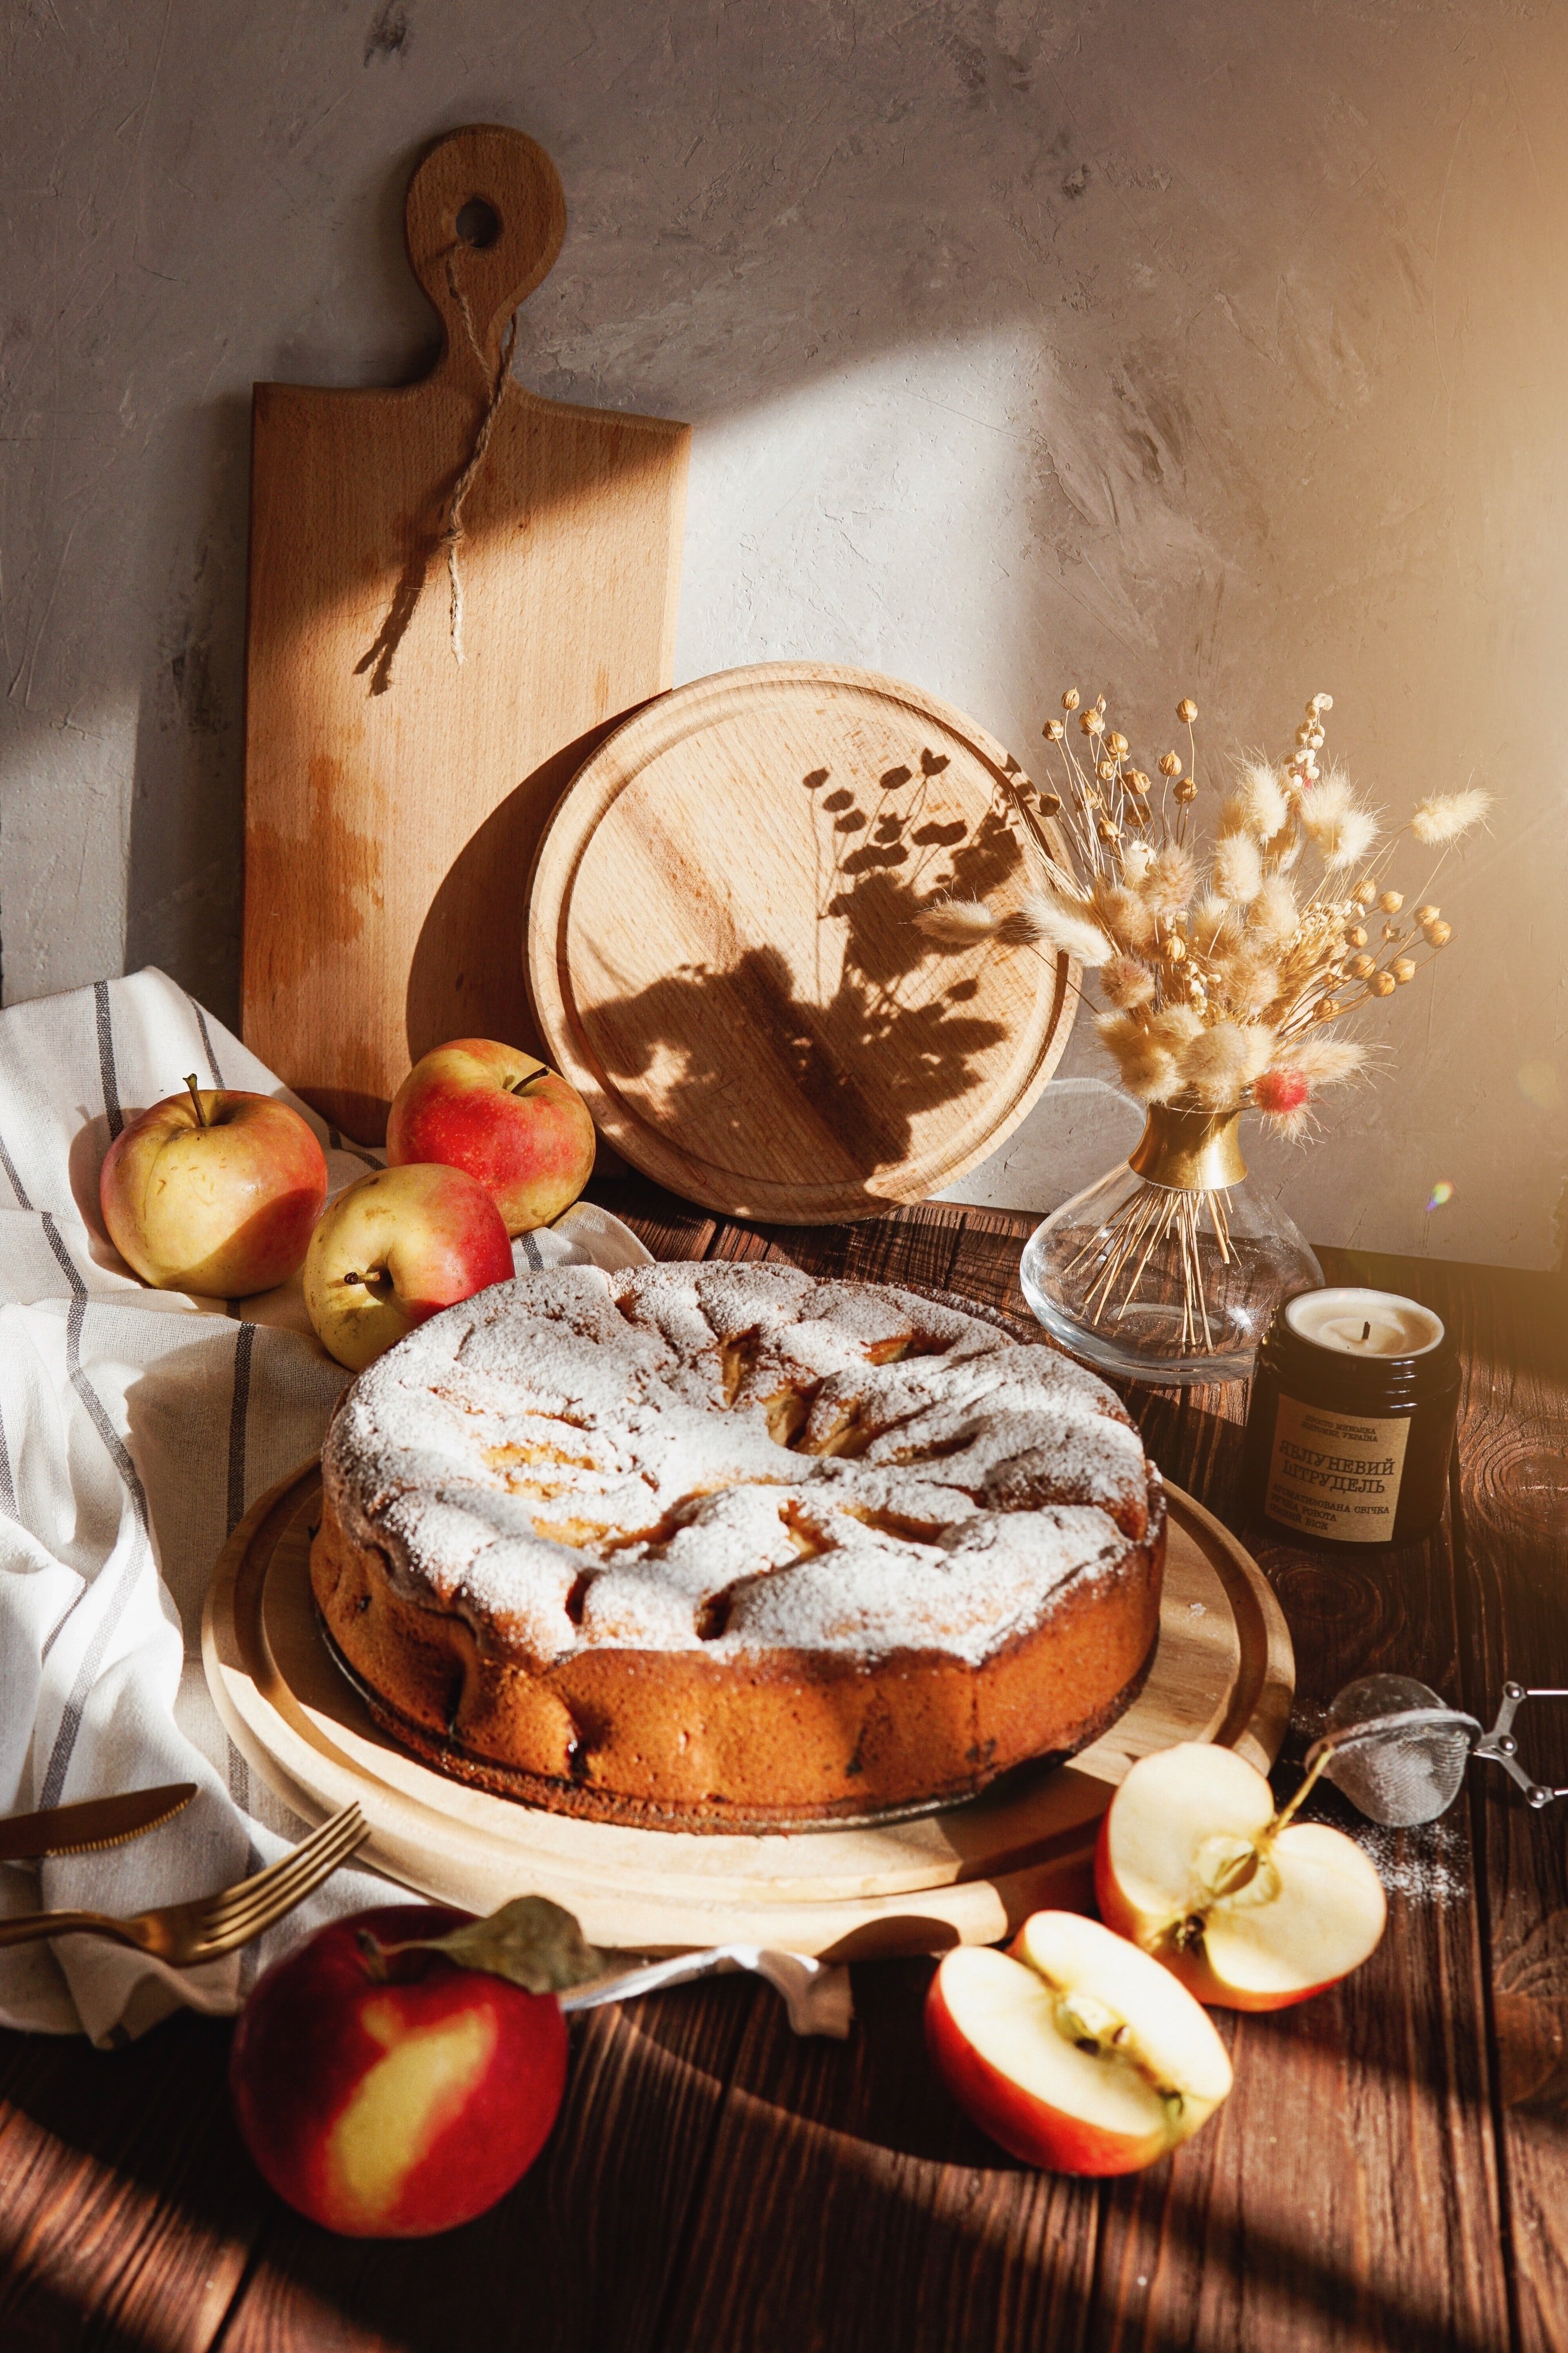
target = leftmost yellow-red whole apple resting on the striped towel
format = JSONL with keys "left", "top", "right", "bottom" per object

{"left": 99, "top": 1078, "right": 327, "bottom": 1299}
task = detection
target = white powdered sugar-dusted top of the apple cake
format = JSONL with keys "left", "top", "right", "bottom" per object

{"left": 325, "top": 1264, "right": 1154, "bottom": 1666}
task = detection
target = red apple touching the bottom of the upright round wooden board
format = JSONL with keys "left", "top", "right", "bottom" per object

{"left": 385, "top": 1037, "right": 595, "bottom": 1233}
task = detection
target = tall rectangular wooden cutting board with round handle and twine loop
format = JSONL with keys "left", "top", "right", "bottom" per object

{"left": 242, "top": 125, "right": 689, "bottom": 1144}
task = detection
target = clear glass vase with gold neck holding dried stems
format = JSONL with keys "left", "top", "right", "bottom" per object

{"left": 1020, "top": 1104, "right": 1323, "bottom": 1386}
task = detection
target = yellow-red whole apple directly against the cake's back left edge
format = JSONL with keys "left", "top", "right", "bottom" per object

{"left": 306, "top": 1165, "right": 512, "bottom": 1372}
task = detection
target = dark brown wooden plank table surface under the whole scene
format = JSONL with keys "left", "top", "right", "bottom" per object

{"left": 0, "top": 1188, "right": 1568, "bottom": 2353}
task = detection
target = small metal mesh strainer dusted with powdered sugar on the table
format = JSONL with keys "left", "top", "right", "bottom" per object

{"left": 1297, "top": 1675, "right": 1568, "bottom": 1831}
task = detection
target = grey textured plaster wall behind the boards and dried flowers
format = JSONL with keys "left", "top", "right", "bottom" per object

{"left": 0, "top": 0, "right": 1568, "bottom": 1266}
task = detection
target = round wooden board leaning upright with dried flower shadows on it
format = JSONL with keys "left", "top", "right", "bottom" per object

{"left": 527, "top": 661, "right": 1077, "bottom": 1224}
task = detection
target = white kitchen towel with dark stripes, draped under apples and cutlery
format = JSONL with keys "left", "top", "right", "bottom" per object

{"left": 0, "top": 972, "right": 647, "bottom": 2042}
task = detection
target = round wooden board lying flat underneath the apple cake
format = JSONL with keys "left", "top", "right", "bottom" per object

{"left": 202, "top": 1464, "right": 1295, "bottom": 1960}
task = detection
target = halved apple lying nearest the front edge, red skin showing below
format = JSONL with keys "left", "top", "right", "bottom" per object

{"left": 926, "top": 1913, "right": 1230, "bottom": 2174}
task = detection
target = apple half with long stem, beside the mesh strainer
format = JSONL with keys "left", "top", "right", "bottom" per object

{"left": 1095, "top": 1741, "right": 1387, "bottom": 2009}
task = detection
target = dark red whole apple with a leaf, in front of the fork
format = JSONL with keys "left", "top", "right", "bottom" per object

{"left": 228, "top": 1904, "right": 566, "bottom": 2238}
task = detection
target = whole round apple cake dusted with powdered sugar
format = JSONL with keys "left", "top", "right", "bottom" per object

{"left": 310, "top": 1264, "right": 1166, "bottom": 1831}
